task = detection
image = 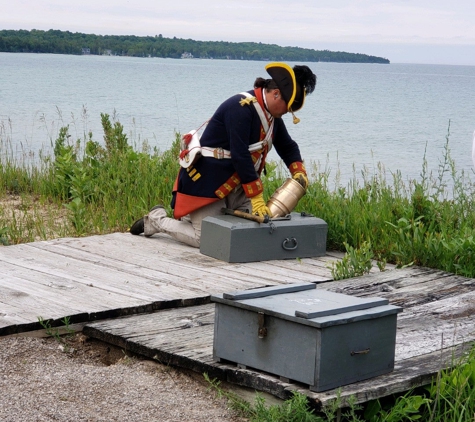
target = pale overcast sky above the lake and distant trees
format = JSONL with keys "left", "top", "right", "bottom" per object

{"left": 0, "top": 0, "right": 475, "bottom": 65}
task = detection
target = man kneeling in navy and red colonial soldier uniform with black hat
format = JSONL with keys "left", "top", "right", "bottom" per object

{"left": 130, "top": 63, "right": 316, "bottom": 247}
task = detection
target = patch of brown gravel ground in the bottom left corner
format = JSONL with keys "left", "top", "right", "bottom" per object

{"left": 0, "top": 333, "right": 245, "bottom": 422}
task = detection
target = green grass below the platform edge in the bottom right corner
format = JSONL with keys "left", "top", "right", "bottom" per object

{"left": 204, "top": 347, "right": 475, "bottom": 422}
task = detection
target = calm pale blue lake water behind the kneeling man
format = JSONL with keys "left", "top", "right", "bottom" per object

{"left": 0, "top": 53, "right": 475, "bottom": 187}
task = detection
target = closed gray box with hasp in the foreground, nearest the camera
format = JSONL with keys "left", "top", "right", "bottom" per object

{"left": 211, "top": 283, "right": 402, "bottom": 392}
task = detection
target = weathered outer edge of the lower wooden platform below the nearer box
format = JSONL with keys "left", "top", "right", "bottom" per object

{"left": 83, "top": 325, "right": 471, "bottom": 408}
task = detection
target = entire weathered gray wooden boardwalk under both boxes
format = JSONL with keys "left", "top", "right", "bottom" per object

{"left": 0, "top": 233, "right": 475, "bottom": 404}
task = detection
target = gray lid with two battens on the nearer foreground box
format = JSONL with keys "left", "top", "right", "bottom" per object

{"left": 211, "top": 283, "right": 402, "bottom": 328}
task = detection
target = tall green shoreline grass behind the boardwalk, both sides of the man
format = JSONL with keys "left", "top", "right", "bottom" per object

{"left": 0, "top": 114, "right": 475, "bottom": 277}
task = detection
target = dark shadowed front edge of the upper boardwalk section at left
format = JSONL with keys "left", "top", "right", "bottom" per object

{"left": 0, "top": 295, "right": 211, "bottom": 337}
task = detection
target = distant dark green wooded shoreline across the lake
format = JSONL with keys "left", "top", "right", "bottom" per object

{"left": 0, "top": 29, "right": 389, "bottom": 63}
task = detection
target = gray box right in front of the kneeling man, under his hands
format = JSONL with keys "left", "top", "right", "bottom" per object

{"left": 200, "top": 213, "right": 328, "bottom": 262}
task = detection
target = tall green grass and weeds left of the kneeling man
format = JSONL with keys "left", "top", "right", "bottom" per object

{"left": 0, "top": 115, "right": 178, "bottom": 244}
